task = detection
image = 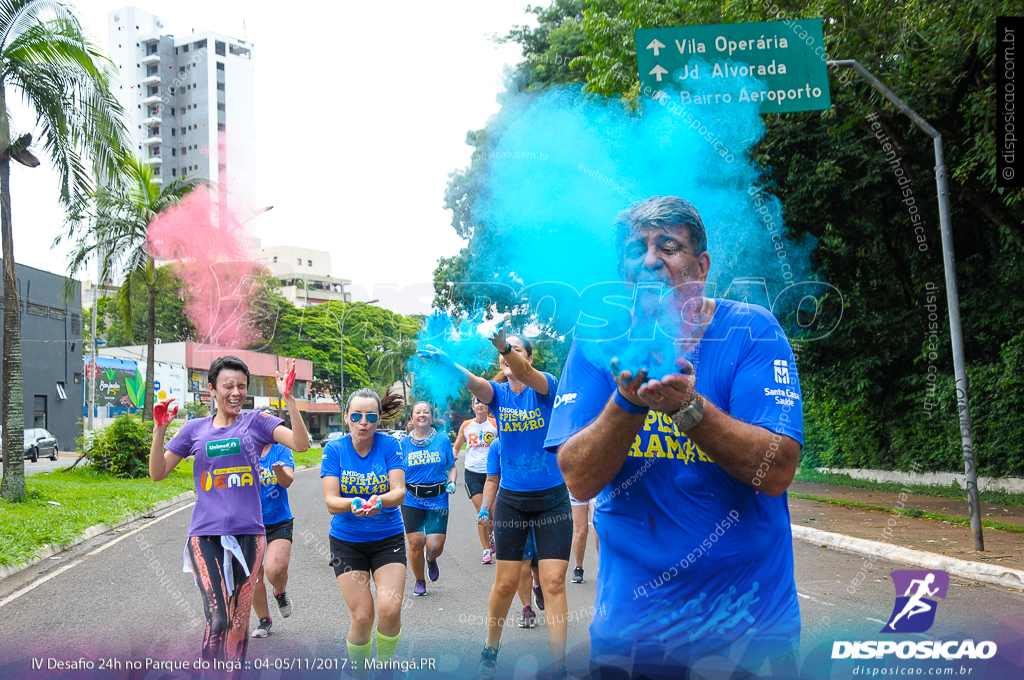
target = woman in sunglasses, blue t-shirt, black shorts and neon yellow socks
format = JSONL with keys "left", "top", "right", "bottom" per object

{"left": 321, "top": 388, "right": 406, "bottom": 677}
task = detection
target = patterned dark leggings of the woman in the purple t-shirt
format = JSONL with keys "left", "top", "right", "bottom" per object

{"left": 188, "top": 534, "right": 266, "bottom": 662}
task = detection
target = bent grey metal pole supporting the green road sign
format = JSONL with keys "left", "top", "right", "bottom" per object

{"left": 826, "top": 59, "right": 985, "bottom": 551}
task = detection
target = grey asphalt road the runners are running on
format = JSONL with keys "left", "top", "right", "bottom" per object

{"left": 0, "top": 456, "right": 1024, "bottom": 678}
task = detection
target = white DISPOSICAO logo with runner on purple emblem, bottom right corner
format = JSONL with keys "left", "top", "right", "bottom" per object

{"left": 831, "top": 569, "right": 996, "bottom": 660}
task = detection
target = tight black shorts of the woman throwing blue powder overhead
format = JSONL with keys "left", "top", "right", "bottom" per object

{"left": 495, "top": 484, "right": 572, "bottom": 561}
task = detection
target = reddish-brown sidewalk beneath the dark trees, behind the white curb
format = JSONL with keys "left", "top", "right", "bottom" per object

{"left": 788, "top": 481, "right": 1024, "bottom": 569}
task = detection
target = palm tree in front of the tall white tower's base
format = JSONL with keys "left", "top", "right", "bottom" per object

{"left": 68, "top": 155, "right": 203, "bottom": 421}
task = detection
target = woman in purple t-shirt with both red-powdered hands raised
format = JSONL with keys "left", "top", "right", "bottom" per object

{"left": 150, "top": 356, "right": 309, "bottom": 662}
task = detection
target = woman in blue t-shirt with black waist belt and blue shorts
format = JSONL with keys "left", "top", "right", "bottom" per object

{"left": 401, "top": 401, "right": 459, "bottom": 595}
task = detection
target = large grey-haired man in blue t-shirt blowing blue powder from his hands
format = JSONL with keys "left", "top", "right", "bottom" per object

{"left": 545, "top": 197, "right": 803, "bottom": 678}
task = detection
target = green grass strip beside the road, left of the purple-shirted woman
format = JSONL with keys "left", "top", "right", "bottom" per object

{"left": 0, "top": 460, "right": 195, "bottom": 566}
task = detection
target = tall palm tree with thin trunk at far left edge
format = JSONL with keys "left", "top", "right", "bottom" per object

{"left": 0, "top": 0, "right": 125, "bottom": 501}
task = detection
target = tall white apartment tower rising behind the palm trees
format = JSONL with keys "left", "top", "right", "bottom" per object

{"left": 108, "top": 7, "right": 256, "bottom": 219}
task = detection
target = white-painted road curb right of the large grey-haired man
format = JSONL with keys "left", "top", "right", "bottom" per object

{"left": 792, "top": 524, "right": 1024, "bottom": 590}
